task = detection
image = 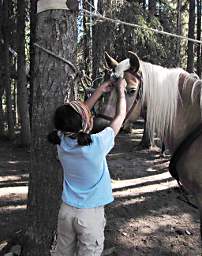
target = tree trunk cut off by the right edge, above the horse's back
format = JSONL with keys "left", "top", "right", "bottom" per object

{"left": 197, "top": 0, "right": 202, "bottom": 77}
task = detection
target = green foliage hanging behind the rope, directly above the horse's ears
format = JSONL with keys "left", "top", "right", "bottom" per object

{"left": 112, "top": 2, "right": 180, "bottom": 67}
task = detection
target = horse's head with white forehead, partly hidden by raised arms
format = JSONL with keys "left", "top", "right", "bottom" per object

{"left": 94, "top": 52, "right": 142, "bottom": 131}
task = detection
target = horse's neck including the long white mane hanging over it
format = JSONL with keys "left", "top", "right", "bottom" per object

{"left": 141, "top": 62, "right": 202, "bottom": 151}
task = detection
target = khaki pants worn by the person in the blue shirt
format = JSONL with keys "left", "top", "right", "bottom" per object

{"left": 52, "top": 203, "right": 106, "bottom": 256}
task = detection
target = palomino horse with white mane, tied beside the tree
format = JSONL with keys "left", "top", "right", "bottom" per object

{"left": 95, "top": 52, "right": 202, "bottom": 240}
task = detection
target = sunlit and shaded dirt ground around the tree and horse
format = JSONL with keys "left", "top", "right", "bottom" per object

{"left": 0, "top": 125, "right": 201, "bottom": 256}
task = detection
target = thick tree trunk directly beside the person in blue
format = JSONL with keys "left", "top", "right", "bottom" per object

{"left": 23, "top": 0, "right": 77, "bottom": 256}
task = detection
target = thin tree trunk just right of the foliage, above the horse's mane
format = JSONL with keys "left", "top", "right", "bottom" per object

{"left": 176, "top": 0, "right": 182, "bottom": 66}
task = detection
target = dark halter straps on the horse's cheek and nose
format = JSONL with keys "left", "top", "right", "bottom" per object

{"left": 95, "top": 70, "right": 143, "bottom": 124}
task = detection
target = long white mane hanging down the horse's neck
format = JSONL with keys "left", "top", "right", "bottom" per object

{"left": 140, "top": 61, "right": 185, "bottom": 140}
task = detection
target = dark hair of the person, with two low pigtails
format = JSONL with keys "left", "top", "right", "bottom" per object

{"left": 48, "top": 105, "right": 92, "bottom": 146}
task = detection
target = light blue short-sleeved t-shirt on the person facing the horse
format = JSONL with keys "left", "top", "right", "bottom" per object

{"left": 57, "top": 127, "right": 115, "bottom": 208}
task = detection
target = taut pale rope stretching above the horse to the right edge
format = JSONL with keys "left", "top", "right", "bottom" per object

{"left": 83, "top": 9, "right": 202, "bottom": 44}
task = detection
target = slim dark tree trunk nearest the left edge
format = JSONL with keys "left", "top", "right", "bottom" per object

{"left": 3, "top": 0, "right": 14, "bottom": 140}
